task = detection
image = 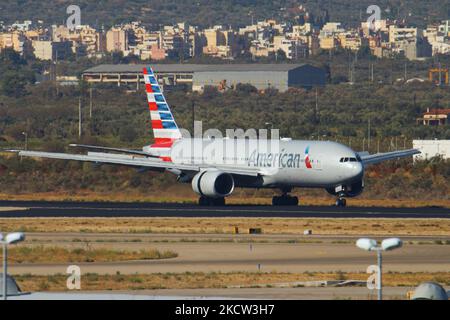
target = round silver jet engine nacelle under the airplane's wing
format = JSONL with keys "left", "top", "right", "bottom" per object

{"left": 192, "top": 171, "right": 234, "bottom": 198}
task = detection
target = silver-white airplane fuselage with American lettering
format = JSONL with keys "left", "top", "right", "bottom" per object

{"left": 144, "top": 139, "right": 364, "bottom": 188}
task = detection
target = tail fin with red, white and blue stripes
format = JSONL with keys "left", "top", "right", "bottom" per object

{"left": 143, "top": 67, "right": 181, "bottom": 148}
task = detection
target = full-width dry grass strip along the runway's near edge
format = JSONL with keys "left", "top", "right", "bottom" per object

{"left": 0, "top": 213, "right": 450, "bottom": 236}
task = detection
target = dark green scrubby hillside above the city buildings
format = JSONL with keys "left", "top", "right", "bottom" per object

{"left": 0, "top": 0, "right": 449, "bottom": 28}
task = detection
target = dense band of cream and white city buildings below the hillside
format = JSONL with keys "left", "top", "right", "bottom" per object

{"left": 0, "top": 1, "right": 450, "bottom": 62}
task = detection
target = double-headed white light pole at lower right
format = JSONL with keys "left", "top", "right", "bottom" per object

{"left": 356, "top": 238, "right": 403, "bottom": 300}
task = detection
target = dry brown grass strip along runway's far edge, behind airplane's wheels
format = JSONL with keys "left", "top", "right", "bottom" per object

{"left": 0, "top": 189, "right": 450, "bottom": 208}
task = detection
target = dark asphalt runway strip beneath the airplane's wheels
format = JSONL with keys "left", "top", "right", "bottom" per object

{"left": 0, "top": 201, "right": 450, "bottom": 219}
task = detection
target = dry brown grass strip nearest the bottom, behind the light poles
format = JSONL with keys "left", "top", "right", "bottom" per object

{"left": 15, "top": 271, "right": 450, "bottom": 291}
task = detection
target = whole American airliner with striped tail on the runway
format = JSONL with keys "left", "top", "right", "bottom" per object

{"left": 7, "top": 67, "right": 420, "bottom": 207}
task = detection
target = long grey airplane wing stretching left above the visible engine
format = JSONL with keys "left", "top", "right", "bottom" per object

{"left": 5, "top": 150, "right": 267, "bottom": 177}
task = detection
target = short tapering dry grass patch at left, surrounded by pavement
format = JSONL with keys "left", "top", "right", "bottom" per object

{"left": 9, "top": 246, "right": 178, "bottom": 264}
